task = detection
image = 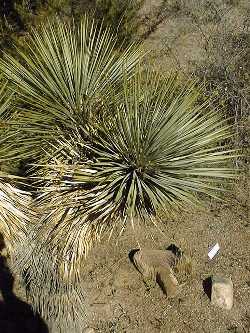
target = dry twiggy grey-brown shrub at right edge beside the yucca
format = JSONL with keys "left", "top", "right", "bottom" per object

{"left": 190, "top": 22, "right": 250, "bottom": 166}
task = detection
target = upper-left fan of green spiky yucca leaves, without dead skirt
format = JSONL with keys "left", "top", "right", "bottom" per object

{"left": 0, "top": 17, "right": 142, "bottom": 159}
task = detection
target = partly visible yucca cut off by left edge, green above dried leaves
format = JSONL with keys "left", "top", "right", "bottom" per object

{"left": 0, "top": 76, "right": 32, "bottom": 252}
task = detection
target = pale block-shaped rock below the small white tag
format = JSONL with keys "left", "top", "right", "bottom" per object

{"left": 211, "top": 275, "right": 233, "bottom": 310}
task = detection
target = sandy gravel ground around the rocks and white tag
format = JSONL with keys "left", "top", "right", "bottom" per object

{"left": 81, "top": 182, "right": 250, "bottom": 333}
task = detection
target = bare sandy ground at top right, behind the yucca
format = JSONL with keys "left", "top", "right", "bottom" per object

{"left": 139, "top": 0, "right": 250, "bottom": 75}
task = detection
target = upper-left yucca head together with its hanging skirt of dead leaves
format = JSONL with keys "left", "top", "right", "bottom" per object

{"left": 0, "top": 17, "right": 142, "bottom": 332}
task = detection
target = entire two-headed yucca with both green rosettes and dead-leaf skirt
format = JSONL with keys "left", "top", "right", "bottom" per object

{"left": 0, "top": 14, "right": 233, "bottom": 332}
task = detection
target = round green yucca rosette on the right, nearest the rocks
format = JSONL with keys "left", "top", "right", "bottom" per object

{"left": 73, "top": 73, "right": 234, "bottom": 223}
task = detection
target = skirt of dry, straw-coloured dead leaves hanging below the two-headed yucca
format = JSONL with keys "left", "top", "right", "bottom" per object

{"left": 13, "top": 175, "right": 94, "bottom": 332}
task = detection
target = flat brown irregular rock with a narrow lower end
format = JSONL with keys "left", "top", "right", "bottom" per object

{"left": 133, "top": 249, "right": 179, "bottom": 297}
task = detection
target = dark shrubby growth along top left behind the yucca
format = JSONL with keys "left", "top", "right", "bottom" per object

{"left": 0, "top": 0, "right": 143, "bottom": 56}
